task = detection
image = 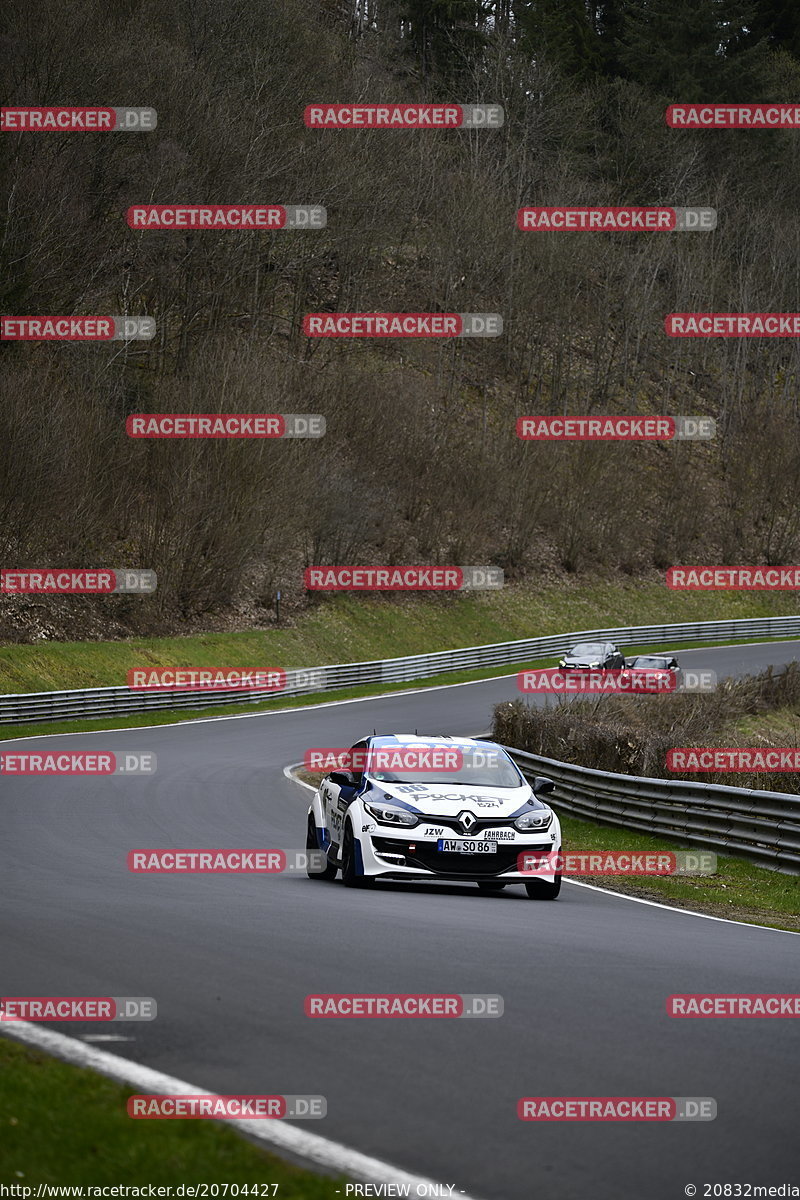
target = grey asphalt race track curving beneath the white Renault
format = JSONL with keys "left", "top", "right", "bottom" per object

{"left": 0, "top": 642, "right": 800, "bottom": 1200}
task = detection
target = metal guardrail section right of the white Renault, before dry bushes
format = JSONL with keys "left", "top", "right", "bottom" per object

{"left": 509, "top": 748, "right": 800, "bottom": 875}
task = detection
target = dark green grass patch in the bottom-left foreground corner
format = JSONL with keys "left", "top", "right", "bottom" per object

{"left": 0, "top": 1037, "right": 336, "bottom": 1185}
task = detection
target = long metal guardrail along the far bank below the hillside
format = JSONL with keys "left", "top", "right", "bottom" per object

{"left": 0, "top": 617, "right": 800, "bottom": 725}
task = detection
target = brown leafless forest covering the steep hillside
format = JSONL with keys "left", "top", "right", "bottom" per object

{"left": 0, "top": 0, "right": 800, "bottom": 636}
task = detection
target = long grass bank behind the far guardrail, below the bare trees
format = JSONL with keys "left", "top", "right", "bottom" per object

{"left": 0, "top": 580, "right": 796, "bottom": 694}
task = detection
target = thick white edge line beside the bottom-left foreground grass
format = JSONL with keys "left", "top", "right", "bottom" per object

{"left": 2, "top": 1021, "right": 482, "bottom": 1200}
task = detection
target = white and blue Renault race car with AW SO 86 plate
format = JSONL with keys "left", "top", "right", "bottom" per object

{"left": 306, "top": 734, "right": 561, "bottom": 900}
